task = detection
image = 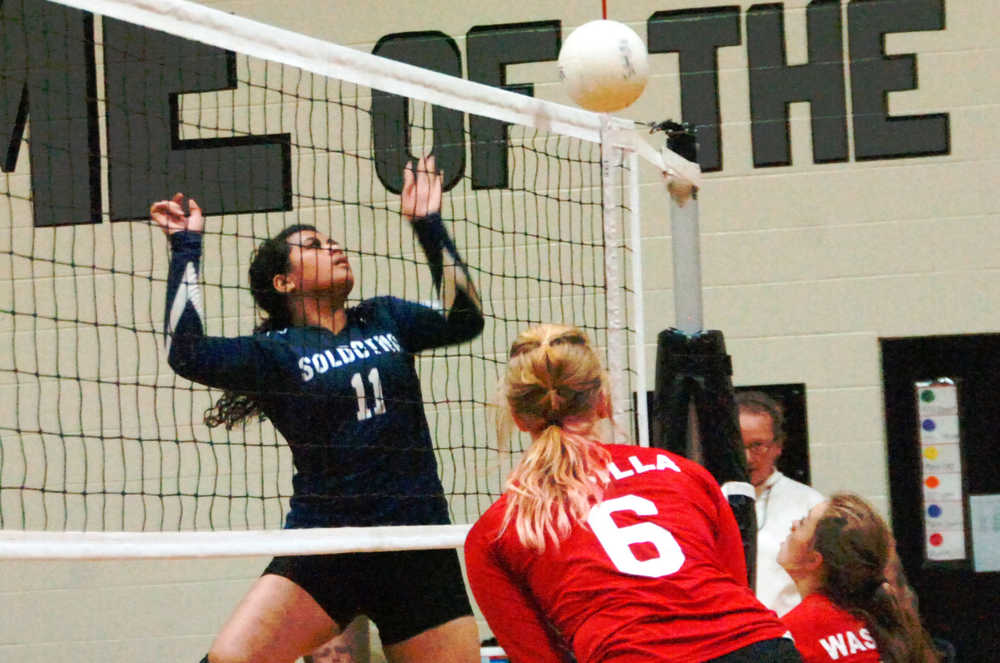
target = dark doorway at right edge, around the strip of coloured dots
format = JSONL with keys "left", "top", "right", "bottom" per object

{"left": 880, "top": 334, "right": 1000, "bottom": 663}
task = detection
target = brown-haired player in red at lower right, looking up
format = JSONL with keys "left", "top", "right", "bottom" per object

{"left": 778, "top": 493, "right": 938, "bottom": 663}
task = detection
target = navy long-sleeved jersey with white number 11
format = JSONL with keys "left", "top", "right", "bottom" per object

{"left": 167, "top": 217, "right": 483, "bottom": 527}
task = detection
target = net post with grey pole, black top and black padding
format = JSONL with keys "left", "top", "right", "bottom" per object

{"left": 650, "top": 120, "right": 757, "bottom": 588}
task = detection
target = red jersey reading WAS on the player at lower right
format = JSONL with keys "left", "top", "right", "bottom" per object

{"left": 781, "top": 594, "right": 880, "bottom": 663}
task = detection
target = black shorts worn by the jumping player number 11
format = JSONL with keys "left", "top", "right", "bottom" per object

{"left": 264, "top": 549, "right": 472, "bottom": 645}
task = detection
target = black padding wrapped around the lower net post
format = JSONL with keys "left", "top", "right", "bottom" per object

{"left": 650, "top": 329, "right": 757, "bottom": 587}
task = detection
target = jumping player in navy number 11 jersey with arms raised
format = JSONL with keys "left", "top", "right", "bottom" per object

{"left": 151, "top": 157, "right": 483, "bottom": 663}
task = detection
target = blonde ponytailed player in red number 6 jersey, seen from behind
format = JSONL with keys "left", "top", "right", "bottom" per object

{"left": 465, "top": 325, "right": 800, "bottom": 663}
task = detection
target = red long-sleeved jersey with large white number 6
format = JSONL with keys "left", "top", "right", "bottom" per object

{"left": 465, "top": 445, "right": 787, "bottom": 663}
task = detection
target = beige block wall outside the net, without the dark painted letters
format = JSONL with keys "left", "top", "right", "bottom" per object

{"left": 0, "top": 0, "right": 1000, "bottom": 663}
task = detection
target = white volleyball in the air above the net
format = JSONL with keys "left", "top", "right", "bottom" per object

{"left": 559, "top": 20, "right": 649, "bottom": 113}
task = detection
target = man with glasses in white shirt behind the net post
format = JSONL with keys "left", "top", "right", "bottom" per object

{"left": 736, "top": 391, "right": 824, "bottom": 617}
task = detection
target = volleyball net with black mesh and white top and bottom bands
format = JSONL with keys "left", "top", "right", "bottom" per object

{"left": 0, "top": 0, "right": 672, "bottom": 558}
